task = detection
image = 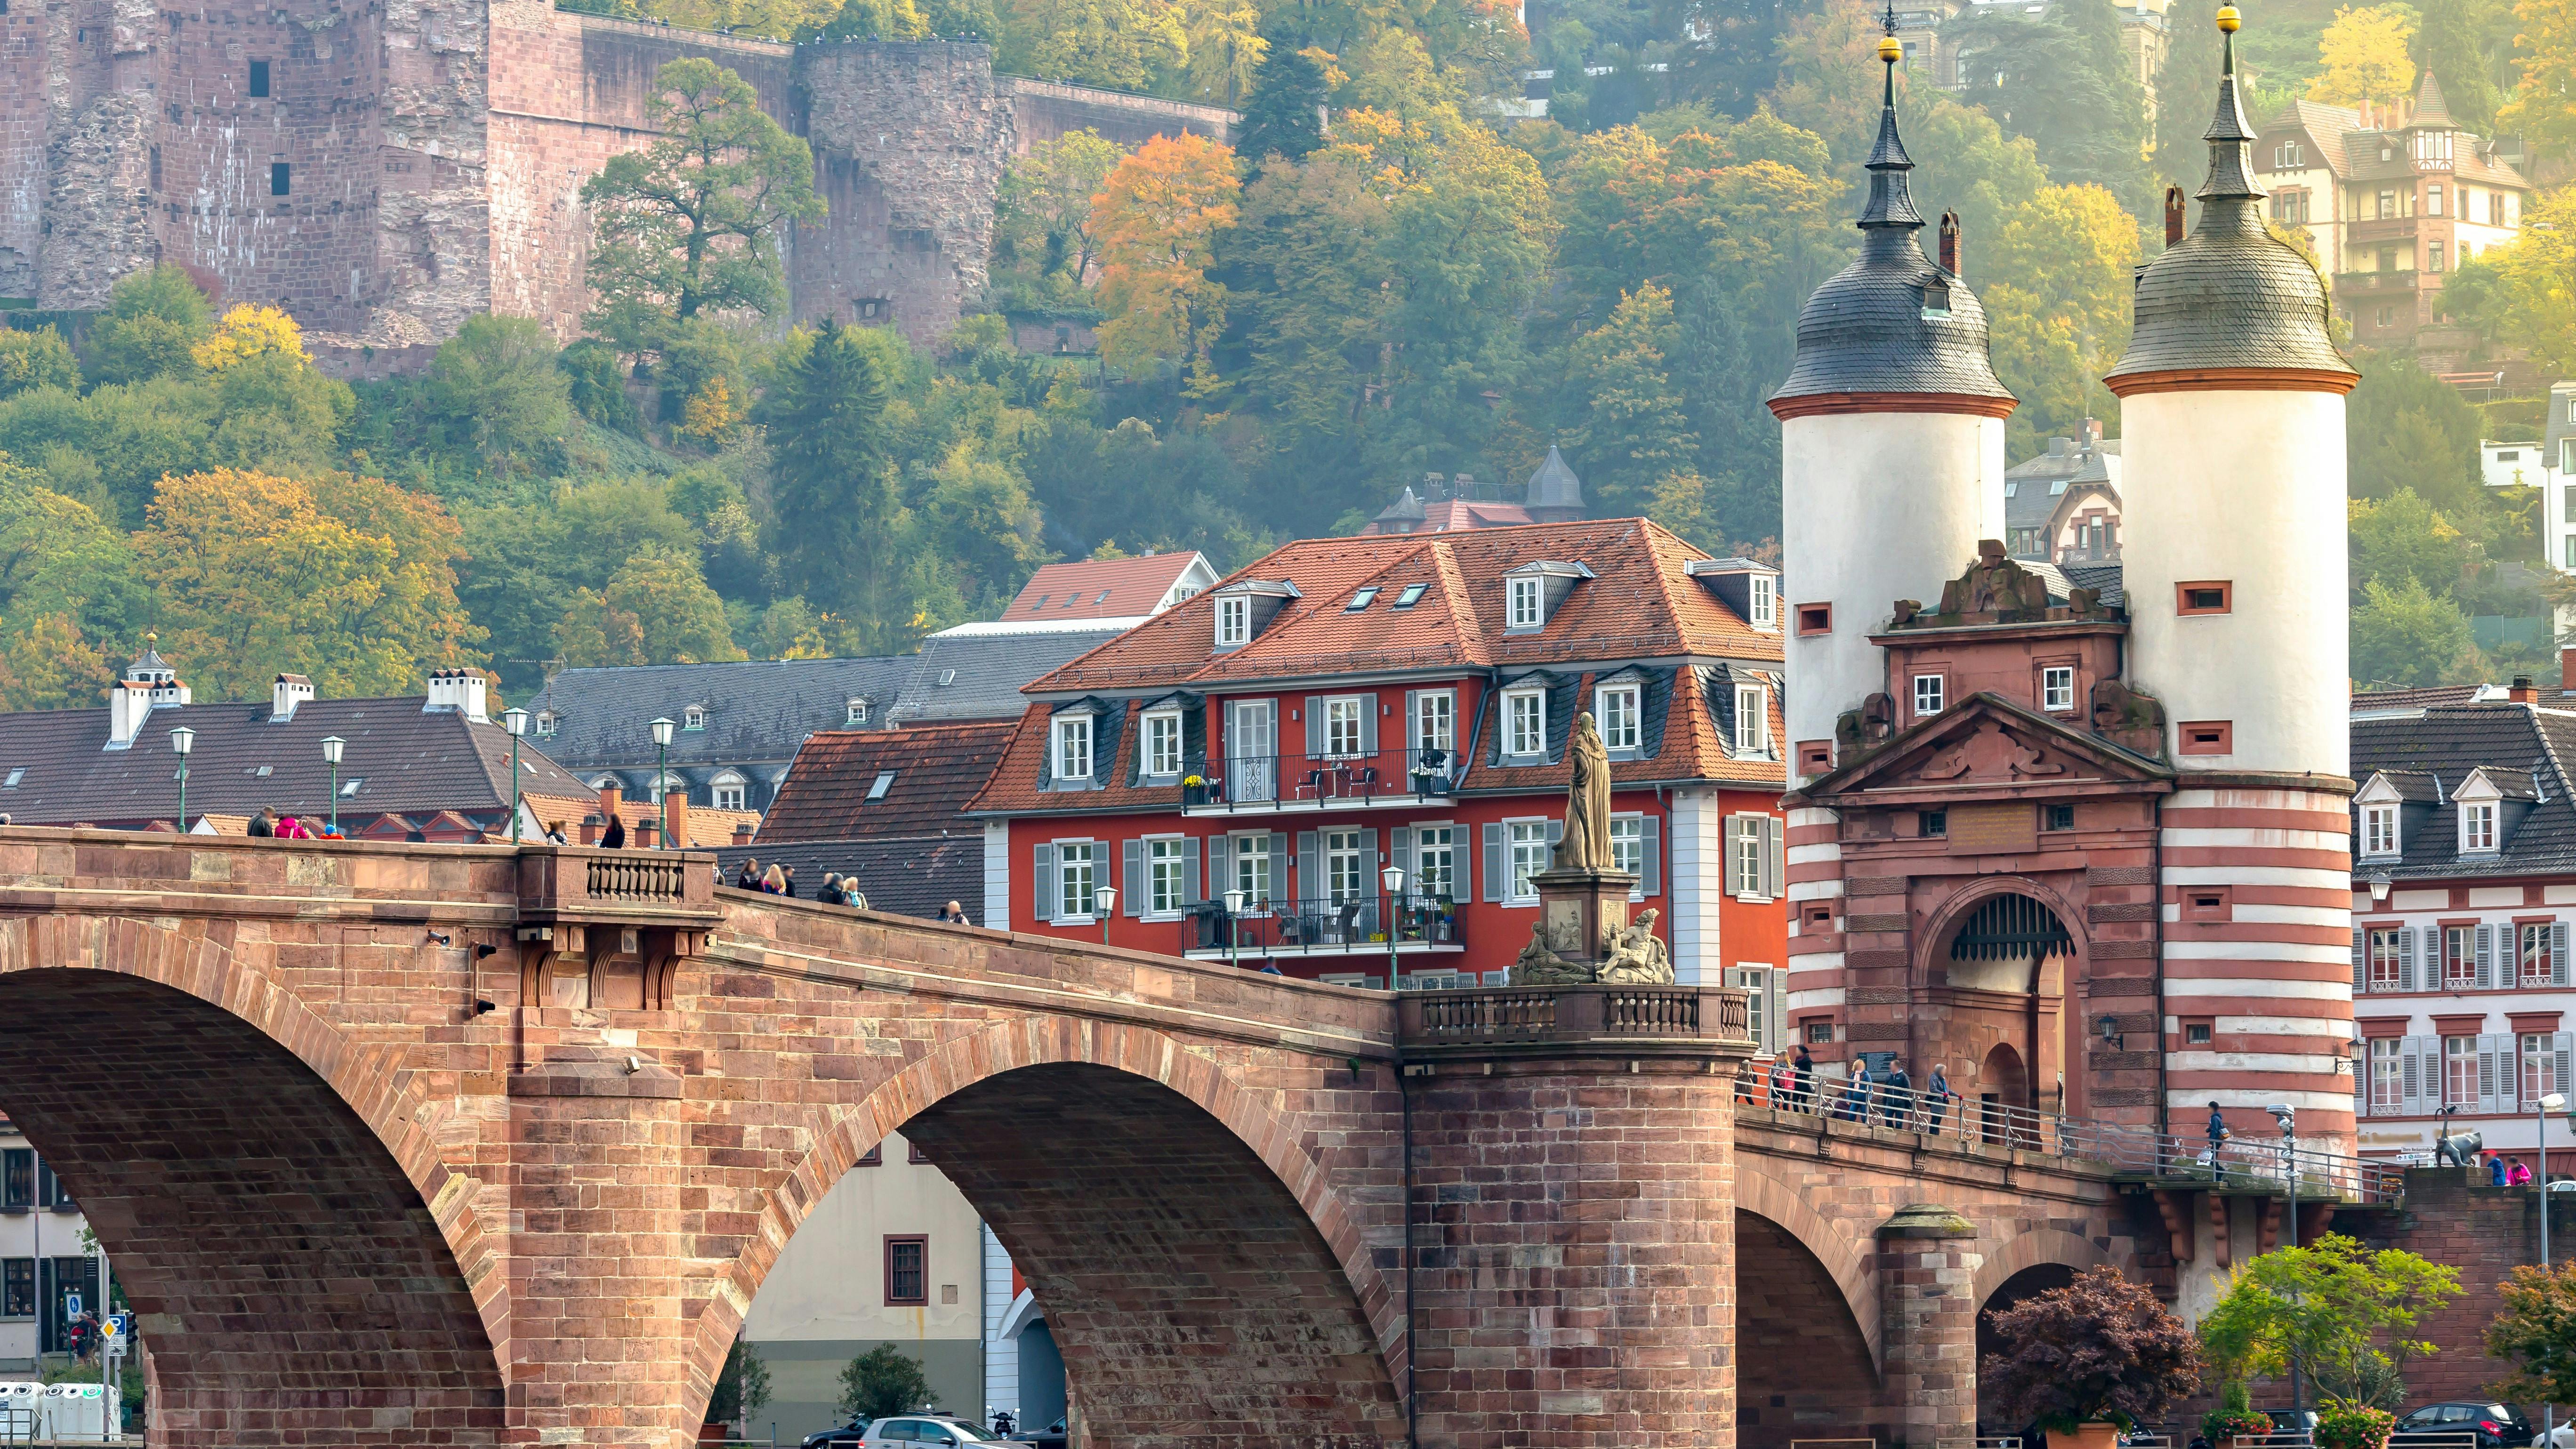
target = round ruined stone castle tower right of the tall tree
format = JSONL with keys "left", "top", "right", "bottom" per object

{"left": 788, "top": 41, "right": 1015, "bottom": 343}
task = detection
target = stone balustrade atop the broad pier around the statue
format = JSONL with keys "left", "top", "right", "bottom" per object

{"left": 1396, "top": 985, "right": 1752, "bottom": 1055}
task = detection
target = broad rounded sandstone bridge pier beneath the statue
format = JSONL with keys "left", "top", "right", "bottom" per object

{"left": 1399, "top": 985, "right": 1752, "bottom": 1449}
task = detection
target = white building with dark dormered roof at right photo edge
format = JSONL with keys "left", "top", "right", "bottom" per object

{"left": 2352, "top": 683, "right": 2576, "bottom": 1170}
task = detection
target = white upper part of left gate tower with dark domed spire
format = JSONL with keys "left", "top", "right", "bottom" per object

{"left": 1770, "top": 31, "right": 2014, "bottom": 789}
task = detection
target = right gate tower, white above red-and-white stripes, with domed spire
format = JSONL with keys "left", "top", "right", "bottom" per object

{"left": 2105, "top": 8, "right": 2357, "bottom": 1152}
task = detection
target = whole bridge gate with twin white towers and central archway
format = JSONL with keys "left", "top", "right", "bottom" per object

{"left": 1770, "top": 10, "right": 2357, "bottom": 1152}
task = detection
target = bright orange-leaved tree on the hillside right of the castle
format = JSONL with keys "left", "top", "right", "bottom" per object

{"left": 1092, "top": 134, "right": 1244, "bottom": 397}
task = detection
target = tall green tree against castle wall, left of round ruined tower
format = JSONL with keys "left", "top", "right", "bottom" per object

{"left": 582, "top": 56, "right": 824, "bottom": 351}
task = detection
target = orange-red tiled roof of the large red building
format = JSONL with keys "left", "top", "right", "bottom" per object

{"left": 1028, "top": 518, "right": 1780, "bottom": 693}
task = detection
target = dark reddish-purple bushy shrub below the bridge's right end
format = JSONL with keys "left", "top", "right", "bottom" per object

{"left": 1978, "top": 1269, "right": 2200, "bottom": 1449}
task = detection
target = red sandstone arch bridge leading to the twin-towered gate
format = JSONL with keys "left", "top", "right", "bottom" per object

{"left": 0, "top": 828, "right": 2166, "bottom": 1449}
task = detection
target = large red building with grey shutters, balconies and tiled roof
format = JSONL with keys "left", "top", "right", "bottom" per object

{"left": 968, "top": 518, "right": 1783, "bottom": 1018}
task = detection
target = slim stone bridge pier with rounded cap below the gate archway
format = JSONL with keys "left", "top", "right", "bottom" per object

{"left": 1878, "top": 1204, "right": 1986, "bottom": 1447}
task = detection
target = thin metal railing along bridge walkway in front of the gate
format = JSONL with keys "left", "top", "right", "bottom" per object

{"left": 1736, "top": 1060, "right": 2406, "bottom": 1201}
